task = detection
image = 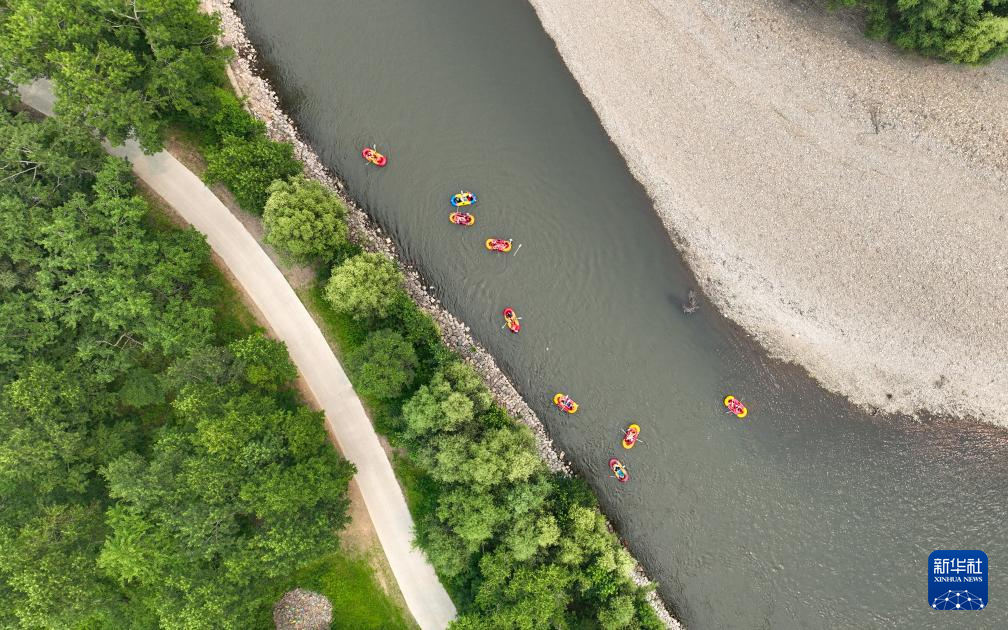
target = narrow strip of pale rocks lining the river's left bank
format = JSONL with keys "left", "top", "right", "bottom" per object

{"left": 201, "top": 0, "right": 682, "bottom": 630}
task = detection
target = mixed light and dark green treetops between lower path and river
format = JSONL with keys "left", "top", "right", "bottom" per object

{"left": 399, "top": 362, "right": 660, "bottom": 630}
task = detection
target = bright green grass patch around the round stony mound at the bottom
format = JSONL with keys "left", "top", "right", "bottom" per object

{"left": 261, "top": 552, "right": 414, "bottom": 630}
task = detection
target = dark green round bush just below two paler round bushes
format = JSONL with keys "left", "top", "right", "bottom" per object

{"left": 347, "top": 329, "right": 416, "bottom": 400}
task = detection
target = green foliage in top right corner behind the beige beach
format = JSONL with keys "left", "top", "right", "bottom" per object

{"left": 840, "top": 0, "right": 1008, "bottom": 64}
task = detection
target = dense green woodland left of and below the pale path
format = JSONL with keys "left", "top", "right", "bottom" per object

{"left": 0, "top": 112, "right": 353, "bottom": 628}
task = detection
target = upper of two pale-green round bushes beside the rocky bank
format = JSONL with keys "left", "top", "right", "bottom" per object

{"left": 262, "top": 175, "right": 349, "bottom": 263}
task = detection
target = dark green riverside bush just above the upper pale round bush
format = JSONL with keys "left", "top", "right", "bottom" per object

{"left": 204, "top": 135, "right": 301, "bottom": 215}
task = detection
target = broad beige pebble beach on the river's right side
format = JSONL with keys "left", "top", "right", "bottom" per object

{"left": 531, "top": 0, "right": 1008, "bottom": 424}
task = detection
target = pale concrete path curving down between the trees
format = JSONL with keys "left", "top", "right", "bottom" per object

{"left": 21, "top": 81, "right": 456, "bottom": 630}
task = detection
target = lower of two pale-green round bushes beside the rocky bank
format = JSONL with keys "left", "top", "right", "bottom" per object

{"left": 326, "top": 252, "right": 405, "bottom": 322}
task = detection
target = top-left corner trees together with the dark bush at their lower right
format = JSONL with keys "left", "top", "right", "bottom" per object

{"left": 0, "top": 0, "right": 301, "bottom": 214}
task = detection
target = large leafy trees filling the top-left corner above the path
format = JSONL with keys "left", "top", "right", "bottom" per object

{"left": 0, "top": 0, "right": 227, "bottom": 150}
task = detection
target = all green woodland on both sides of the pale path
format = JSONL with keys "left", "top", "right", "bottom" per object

{"left": 0, "top": 0, "right": 661, "bottom": 629}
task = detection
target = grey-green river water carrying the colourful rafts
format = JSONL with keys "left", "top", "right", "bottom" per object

{"left": 236, "top": 0, "right": 1008, "bottom": 629}
